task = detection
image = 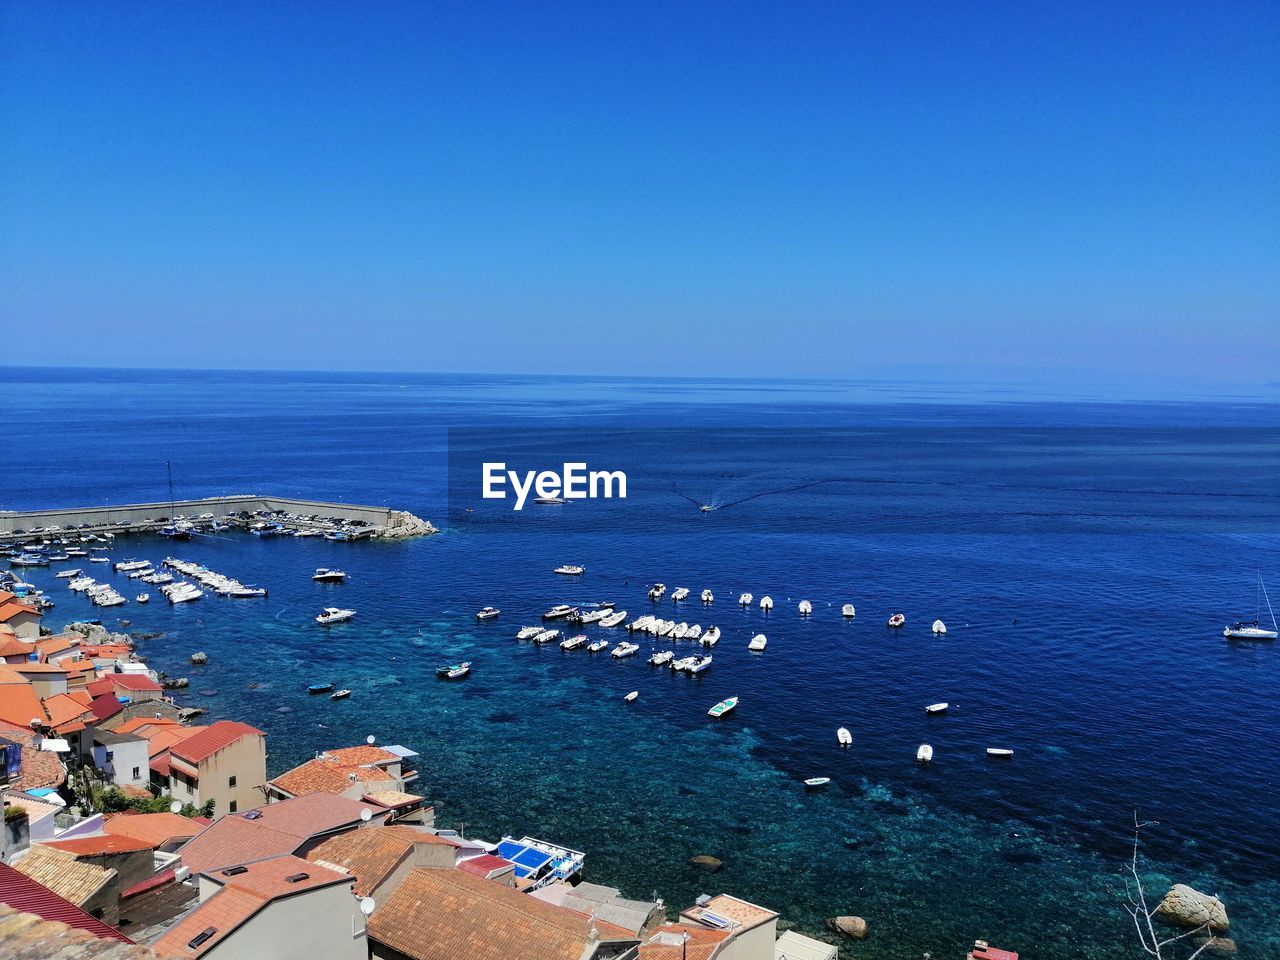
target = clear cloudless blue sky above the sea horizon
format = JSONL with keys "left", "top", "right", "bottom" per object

{"left": 0, "top": 0, "right": 1280, "bottom": 381}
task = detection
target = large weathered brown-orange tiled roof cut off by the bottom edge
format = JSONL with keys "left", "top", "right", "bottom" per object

{"left": 369, "top": 868, "right": 635, "bottom": 960}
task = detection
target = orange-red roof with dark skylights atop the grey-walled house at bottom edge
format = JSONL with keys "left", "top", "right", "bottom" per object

{"left": 151, "top": 856, "right": 351, "bottom": 957}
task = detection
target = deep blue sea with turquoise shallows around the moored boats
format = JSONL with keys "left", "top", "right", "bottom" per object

{"left": 0, "top": 369, "right": 1280, "bottom": 960}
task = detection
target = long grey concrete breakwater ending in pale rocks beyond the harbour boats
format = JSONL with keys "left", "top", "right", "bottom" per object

{"left": 0, "top": 494, "right": 438, "bottom": 540}
